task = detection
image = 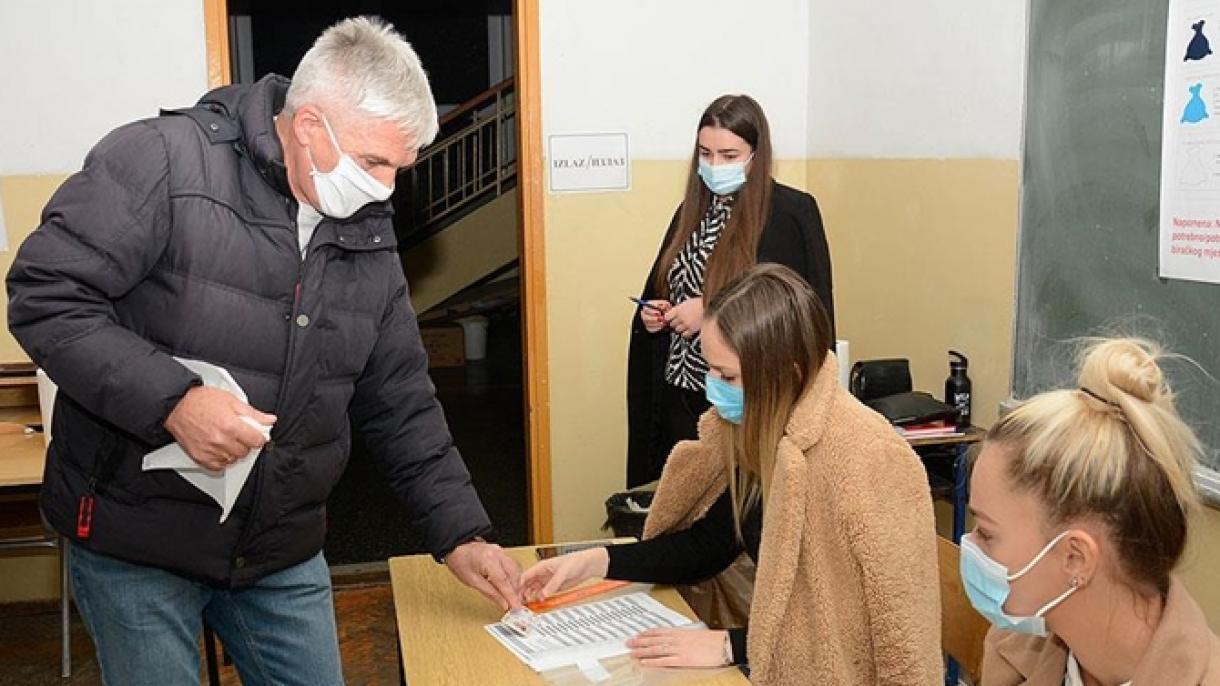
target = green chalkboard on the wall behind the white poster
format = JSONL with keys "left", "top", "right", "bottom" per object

{"left": 1015, "top": 0, "right": 1220, "bottom": 482}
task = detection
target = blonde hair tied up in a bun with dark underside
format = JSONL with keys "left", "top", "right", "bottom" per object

{"left": 987, "top": 338, "right": 1203, "bottom": 592}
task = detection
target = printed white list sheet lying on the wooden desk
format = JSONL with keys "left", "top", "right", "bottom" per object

{"left": 486, "top": 592, "right": 703, "bottom": 681}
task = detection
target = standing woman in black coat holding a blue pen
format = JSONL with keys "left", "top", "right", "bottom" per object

{"left": 627, "top": 95, "right": 834, "bottom": 488}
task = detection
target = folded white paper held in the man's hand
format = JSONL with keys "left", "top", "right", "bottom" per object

{"left": 144, "top": 358, "right": 271, "bottom": 524}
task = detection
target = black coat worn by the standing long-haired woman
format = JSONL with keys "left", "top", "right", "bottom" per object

{"left": 627, "top": 183, "right": 834, "bottom": 488}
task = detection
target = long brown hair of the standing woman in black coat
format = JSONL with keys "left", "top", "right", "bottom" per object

{"left": 653, "top": 95, "right": 772, "bottom": 298}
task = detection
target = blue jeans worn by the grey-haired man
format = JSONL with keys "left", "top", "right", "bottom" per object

{"left": 68, "top": 547, "right": 343, "bottom": 686}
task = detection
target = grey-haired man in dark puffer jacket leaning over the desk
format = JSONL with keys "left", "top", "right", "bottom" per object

{"left": 7, "top": 18, "right": 520, "bottom": 686}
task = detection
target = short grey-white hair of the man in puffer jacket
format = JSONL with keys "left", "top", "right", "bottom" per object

{"left": 283, "top": 17, "right": 438, "bottom": 148}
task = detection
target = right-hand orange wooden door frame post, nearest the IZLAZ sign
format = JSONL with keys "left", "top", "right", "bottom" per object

{"left": 514, "top": 0, "right": 555, "bottom": 543}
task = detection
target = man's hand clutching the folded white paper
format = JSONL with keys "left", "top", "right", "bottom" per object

{"left": 165, "top": 386, "right": 276, "bottom": 471}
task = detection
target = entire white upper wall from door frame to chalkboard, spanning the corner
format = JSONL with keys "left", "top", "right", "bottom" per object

{"left": 540, "top": 0, "right": 1026, "bottom": 160}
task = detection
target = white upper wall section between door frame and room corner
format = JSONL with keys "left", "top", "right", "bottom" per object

{"left": 539, "top": 0, "right": 809, "bottom": 160}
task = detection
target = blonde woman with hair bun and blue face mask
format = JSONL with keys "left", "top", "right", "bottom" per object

{"left": 961, "top": 338, "right": 1220, "bottom": 686}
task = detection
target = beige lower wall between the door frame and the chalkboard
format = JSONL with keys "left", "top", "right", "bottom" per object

{"left": 545, "top": 160, "right": 1017, "bottom": 540}
